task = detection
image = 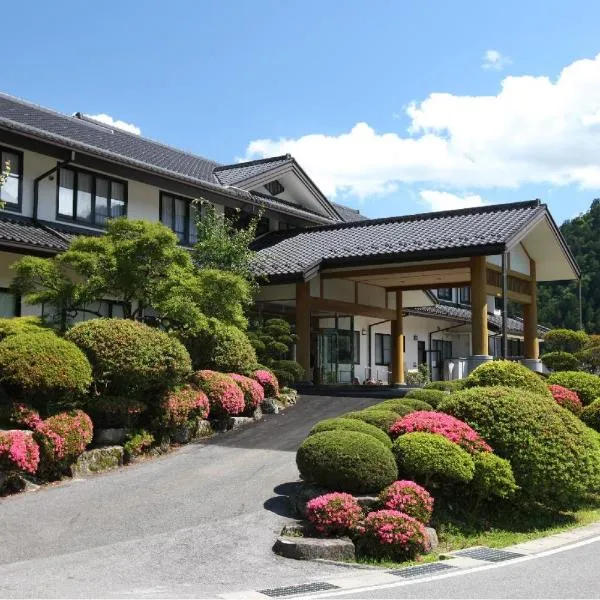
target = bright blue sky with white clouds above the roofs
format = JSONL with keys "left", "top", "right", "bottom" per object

{"left": 5, "top": 0, "right": 600, "bottom": 221}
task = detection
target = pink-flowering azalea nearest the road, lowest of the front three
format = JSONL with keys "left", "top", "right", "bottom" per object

{"left": 357, "top": 510, "right": 429, "bottom": 562}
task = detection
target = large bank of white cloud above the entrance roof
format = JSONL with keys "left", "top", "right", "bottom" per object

{"left": 246, "top": 55, "right": 600, "bottom": 197}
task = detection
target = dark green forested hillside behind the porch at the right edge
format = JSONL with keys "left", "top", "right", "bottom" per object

{"left": 538, "top": 199, "right": 600, "bottom": 333}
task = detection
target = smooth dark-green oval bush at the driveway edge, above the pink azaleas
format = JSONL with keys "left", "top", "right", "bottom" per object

{"left": 296, "top": 430, "right": 398, "bottom": 494}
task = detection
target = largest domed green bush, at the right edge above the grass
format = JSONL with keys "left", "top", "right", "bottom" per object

{"left": 438, "top": 387, "right": 600, "bottom": 508}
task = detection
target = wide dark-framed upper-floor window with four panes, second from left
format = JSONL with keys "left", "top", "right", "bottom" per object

{"left": 57, "top": 167, "right": 127, "bottom": 227}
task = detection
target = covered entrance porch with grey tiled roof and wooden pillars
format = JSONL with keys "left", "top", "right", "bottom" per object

{"left": 251, "top": 201, "right": 579, "bottom": 385}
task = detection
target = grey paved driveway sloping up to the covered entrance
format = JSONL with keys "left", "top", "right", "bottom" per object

{"left": 0, "top": 396, "right": 377, "bottom": 597}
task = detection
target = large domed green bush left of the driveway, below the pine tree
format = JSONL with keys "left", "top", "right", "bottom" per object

{"left": 65, "top": 319, "right": 191, "bottom": 402}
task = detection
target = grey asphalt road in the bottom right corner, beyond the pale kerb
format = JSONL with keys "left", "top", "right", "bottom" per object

{"left": 310, "top": 538, "right": 600, "bottom": 600}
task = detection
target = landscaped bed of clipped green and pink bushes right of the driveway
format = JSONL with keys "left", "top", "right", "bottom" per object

{"left": 276, "top": 356, "right": 600, "bottom": 564}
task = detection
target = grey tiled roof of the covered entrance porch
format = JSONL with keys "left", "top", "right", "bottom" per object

{"left": 256, "top": 200, "right": 546, "bottom": 278}
